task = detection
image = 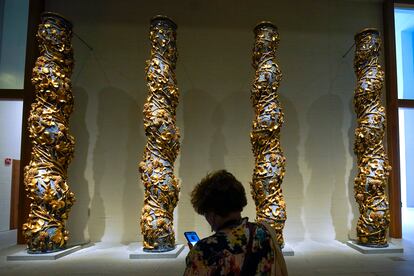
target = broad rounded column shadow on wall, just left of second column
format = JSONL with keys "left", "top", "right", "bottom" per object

{"left": 89, "top": 86, "right": 145, "bottom": 241}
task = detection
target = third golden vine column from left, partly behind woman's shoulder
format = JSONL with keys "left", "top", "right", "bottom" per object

{"left": 250, "top": 22, "right": 286, "bottom": 247}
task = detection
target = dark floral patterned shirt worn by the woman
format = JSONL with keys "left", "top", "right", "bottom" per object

{"left": 184, "top": 218, "right": 274, "bottom": 275}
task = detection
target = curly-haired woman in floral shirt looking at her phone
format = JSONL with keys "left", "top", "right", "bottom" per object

{"left": 184, "top": 170, "right": 287, "bottom": 275}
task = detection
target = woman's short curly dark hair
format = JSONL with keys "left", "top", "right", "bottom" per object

{"left": 191, "top": 170, "right": 247, "bottom": 217}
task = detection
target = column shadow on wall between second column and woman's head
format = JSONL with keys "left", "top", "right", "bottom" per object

{"left": 177, "top": 88, "right": 218, "bottom": 239}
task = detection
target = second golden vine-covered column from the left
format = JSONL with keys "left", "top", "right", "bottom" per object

{"left": 139, "top": 16, "right": 180, "bottom": 252}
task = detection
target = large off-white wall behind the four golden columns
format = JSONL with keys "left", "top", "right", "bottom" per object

{"left": 46, "top": 0, "right": 382, "bottom": 245}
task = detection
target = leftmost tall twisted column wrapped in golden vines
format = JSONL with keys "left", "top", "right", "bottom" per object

{"left": 23, "top": 13, "right": 75, "bottom": 253}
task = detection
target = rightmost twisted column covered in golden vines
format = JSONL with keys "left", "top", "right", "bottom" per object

{"left": 354, "top": 29, "right": 391, "bottom": 247}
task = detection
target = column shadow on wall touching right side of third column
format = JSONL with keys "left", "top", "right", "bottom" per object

{"left": 279, "top": 95, "right": 305, "bottom": 242}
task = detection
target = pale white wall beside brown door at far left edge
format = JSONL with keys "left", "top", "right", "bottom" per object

{"left": 0, "top": 100, "right": 23, "bottom": 231}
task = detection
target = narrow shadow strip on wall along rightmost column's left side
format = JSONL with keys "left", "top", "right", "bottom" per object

{"left": 347, "top": 98, "right": 359, "bottom": 239}
